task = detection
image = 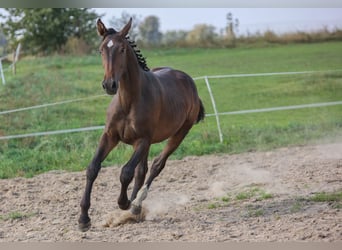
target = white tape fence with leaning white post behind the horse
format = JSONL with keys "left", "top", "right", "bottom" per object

{"left": 0, "top": 69, "right": 342, "bottom": 142}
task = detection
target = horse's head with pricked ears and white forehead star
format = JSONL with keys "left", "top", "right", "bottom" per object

{"left": 97, "top": 18, "right": 132, "bottom": 95}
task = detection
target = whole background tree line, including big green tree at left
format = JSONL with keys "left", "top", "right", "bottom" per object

{"left": 0, "top": 8, "right": 342, "bottom": 55}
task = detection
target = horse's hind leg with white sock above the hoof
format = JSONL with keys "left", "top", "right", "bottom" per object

{"left": 131, "top": 126, "right": 191, "bottom": 214}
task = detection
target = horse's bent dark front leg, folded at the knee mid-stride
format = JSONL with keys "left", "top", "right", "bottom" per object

{"left": 118, "top": 139, "right": 150, "bottom": 210}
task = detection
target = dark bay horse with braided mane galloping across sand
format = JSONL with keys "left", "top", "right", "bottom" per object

{"left": 78, "top": 18, "right": 205, "bottom": 231}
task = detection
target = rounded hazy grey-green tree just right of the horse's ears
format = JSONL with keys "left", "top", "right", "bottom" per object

{"left": 139, "top": 16, "right": 162, "bottom": 47}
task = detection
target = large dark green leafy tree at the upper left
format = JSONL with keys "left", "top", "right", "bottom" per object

{"left": 2, "top": 8, "right": 97, "bottom": 55}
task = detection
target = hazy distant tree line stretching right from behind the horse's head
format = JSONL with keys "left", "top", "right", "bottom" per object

{"left": 110, "top": 12, "right": 342, "bottom": 48}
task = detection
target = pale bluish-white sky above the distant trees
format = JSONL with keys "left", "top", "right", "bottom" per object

{"left": 95, "top": 8, "right": 342, "bottom": 34}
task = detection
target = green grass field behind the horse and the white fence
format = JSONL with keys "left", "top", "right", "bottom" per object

{"left": 0, "top": 42, "right": 342, "bottom": 178}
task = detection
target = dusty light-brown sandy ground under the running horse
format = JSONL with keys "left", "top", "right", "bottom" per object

{"left": 0, "top": 143, "right": 342, "bottom": 242}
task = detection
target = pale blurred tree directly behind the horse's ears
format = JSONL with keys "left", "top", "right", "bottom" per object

{"left": 110, "top": 11, "right": 141, "bottom": 40}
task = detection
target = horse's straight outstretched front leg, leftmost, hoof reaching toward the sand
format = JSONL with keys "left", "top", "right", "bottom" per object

{"left": 78, "top": 133, "right": 118, "bottom": 231}
